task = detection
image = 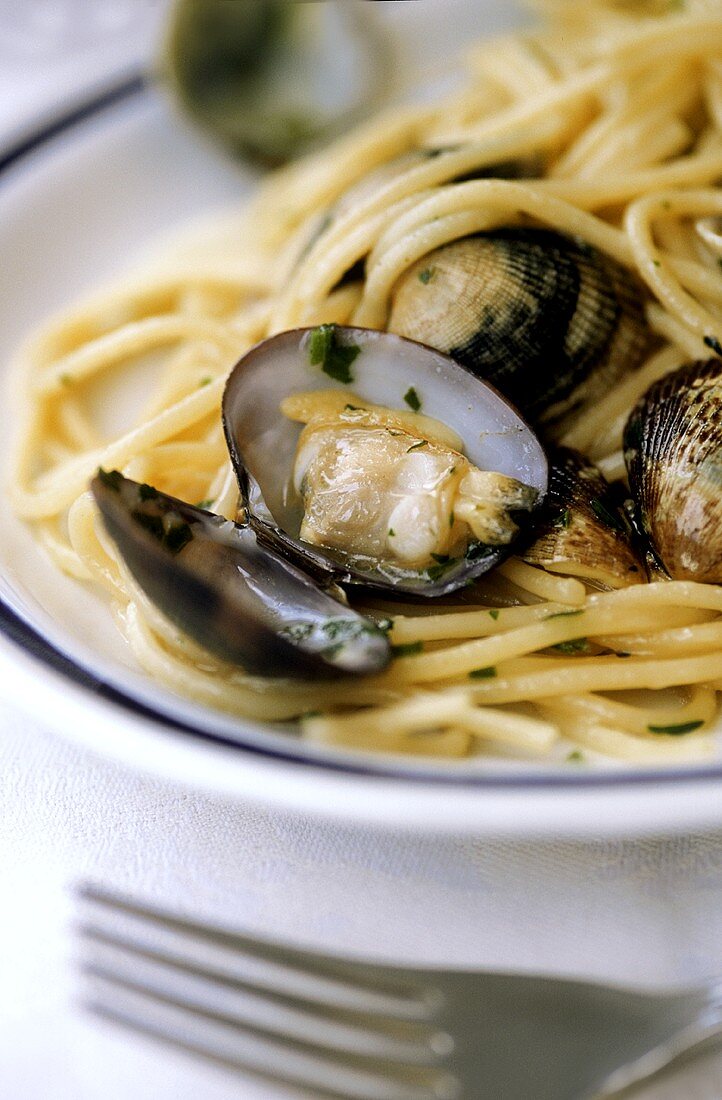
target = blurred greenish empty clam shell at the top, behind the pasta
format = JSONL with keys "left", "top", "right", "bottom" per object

{"left": 161, "top": 0, "right": 391, "bottom": 165}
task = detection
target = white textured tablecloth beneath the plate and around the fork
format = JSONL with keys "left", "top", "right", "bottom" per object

{"left": 0, "top": 705, "right": 722, "bottom": 1100}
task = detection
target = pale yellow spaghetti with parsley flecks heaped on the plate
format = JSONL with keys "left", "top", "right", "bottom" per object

{"left": 10, "top": 0, "right": 722, "bottom": 761}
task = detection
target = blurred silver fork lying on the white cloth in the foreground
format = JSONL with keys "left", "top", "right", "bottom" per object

{"left": 77, "top": 884, "right": 722, "bottom": 1100}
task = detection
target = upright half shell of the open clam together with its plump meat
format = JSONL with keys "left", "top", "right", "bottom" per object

{"left": 223, "top": 325, "right": 547, "bottom": 596}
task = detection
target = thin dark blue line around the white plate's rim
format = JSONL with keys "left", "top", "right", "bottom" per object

{"left": 0, "top": 79, "right": 722, "bottom": 791}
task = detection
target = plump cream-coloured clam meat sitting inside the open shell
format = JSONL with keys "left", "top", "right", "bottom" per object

{"left": 281, "top": 389, "right": 538, "bottom": 570}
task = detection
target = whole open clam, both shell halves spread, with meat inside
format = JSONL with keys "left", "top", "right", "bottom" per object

{"left": 91, "top": 325, "right": 547, "bottom": 678}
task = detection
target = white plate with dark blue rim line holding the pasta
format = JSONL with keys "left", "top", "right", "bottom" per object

{"left": 0, "top": 73, "right": 722, "bottom": 835}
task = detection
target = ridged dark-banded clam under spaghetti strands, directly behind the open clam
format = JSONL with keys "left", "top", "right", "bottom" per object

{"left": 387, "top": 229, "right": 652, "bottom": 438}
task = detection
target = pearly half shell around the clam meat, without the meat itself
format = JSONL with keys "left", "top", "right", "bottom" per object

{"left": 223, "top": 326, "right": 548, "bottom": 596}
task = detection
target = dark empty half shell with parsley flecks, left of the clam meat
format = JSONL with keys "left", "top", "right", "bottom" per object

{"left": 91, "top": 471, "right": 390, "bottom": 678}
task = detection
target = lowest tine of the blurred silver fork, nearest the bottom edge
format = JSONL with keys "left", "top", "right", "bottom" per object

{"left": 84, "top": 975, "right": 459, "bottom": 1100}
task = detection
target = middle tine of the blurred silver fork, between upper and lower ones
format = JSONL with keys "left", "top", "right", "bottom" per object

{"left": 80, "top": 930, "right": 453, "bottom": 1065}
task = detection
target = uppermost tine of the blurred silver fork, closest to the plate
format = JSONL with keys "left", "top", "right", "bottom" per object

{"left": 78, "top": 884, "right": 444, "bottom": 1021}
